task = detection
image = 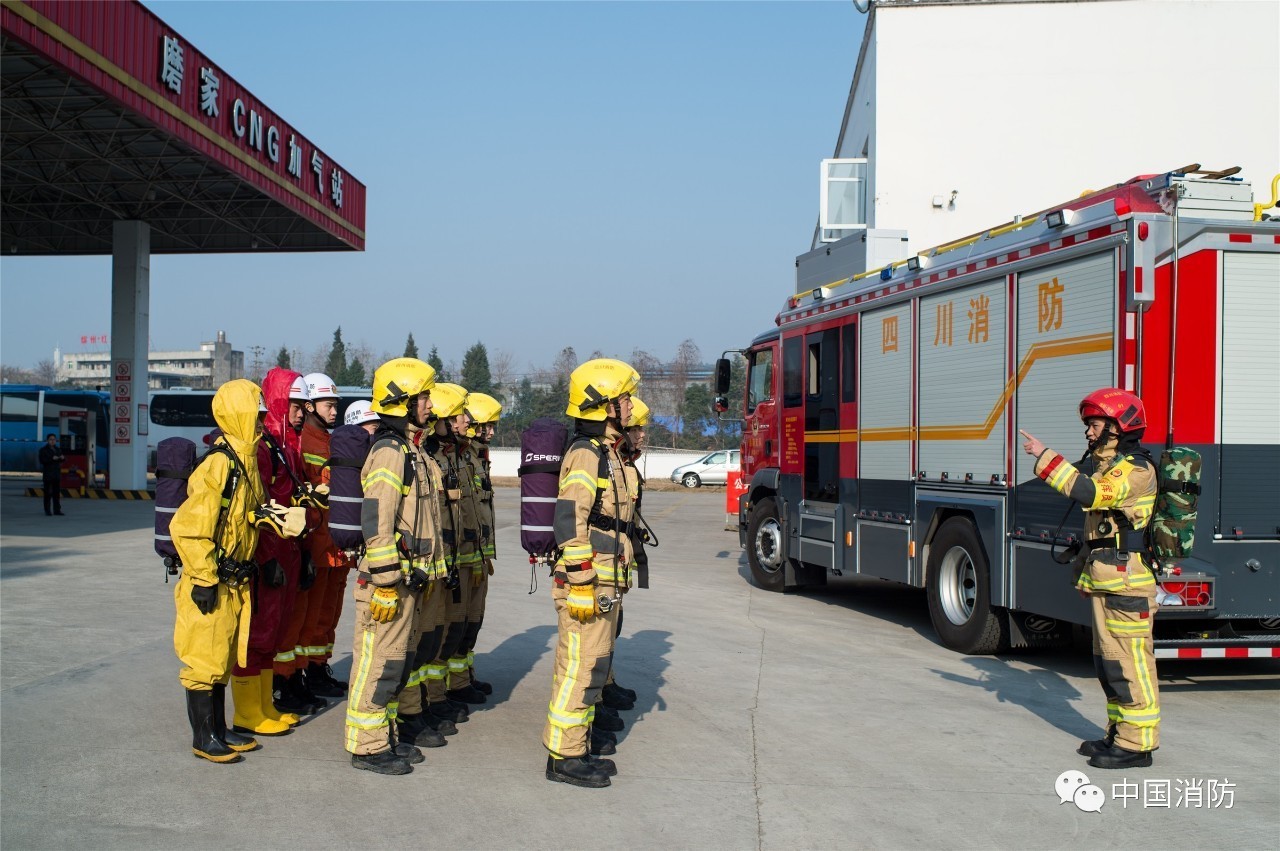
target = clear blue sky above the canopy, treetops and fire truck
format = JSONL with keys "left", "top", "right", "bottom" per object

{"left": 0, "top": 0, "right": 863, "bottom": 372}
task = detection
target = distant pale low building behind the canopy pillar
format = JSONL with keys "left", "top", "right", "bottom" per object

{"left": 54, "top": 331, "right": 244, "bottom": 390}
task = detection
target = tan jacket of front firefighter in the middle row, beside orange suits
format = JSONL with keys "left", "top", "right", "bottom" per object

{"left": 360, "top": 424, "right": 445, "bottom": 586}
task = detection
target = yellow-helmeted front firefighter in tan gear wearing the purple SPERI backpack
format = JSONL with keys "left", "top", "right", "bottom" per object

{"left": 543, "top": 358, "right": 640, "bottom": 788}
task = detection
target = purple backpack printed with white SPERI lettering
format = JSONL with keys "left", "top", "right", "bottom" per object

{"left": 517, "top": 417, "right": 568, "bottom": 563}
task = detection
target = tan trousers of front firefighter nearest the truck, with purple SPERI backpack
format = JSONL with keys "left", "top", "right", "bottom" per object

{"left": 543, "top": 585, "right": 617, "bottom": 759}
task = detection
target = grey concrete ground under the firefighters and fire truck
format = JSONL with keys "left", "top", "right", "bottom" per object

{"left": 0, "top": 480, "right": 1280, "bottom": 850}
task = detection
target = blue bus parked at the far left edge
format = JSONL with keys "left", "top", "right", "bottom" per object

{"left": 0, "top": 384, "right": 111, "bottom": 472}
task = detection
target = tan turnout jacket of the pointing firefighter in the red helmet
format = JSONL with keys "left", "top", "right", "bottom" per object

{"left": 1036, "top": 441, "right": 1158, "bottom": 596}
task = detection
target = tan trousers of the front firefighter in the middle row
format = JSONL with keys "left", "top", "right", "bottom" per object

{"left": 343, "top": 584, "right": 419, "bottom": 755}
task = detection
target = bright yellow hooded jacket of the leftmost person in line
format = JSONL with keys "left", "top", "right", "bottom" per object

{"left": 169, "top": 379, "right": 264, "bottom": 587}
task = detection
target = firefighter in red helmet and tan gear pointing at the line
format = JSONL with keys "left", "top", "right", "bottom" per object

{"left": 1021, "top": 388, "right": 1160, "bottom": 768}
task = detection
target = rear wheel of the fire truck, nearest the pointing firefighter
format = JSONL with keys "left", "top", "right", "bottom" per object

{"left": 925, "top": 517, "right": 1007, "bottom": 655}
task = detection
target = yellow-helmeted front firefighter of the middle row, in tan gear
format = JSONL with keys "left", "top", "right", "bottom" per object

{"left": 344, "top": 357, "right": 442, "bottom": 774}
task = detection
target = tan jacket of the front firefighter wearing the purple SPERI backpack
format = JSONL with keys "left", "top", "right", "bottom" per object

{"left": 553, "top": 422, "right": 637, "bottom": 589}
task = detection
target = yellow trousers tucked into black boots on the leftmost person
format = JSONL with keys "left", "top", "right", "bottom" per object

{"left": 173, "top": 575, "right": 251, "bottom": 691}
